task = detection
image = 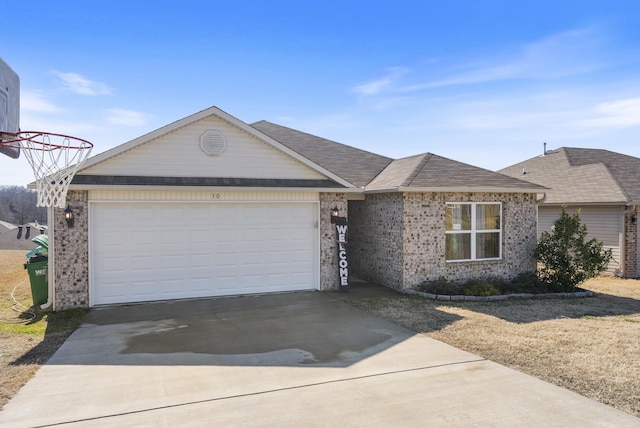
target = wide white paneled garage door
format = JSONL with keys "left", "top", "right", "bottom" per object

{"left": 90, "top": 203, "right": 319, "bottom": 305}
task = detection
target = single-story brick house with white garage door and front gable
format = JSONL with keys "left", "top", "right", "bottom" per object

{"left": 49, "top": 107, "right": 545, "bottom": 310}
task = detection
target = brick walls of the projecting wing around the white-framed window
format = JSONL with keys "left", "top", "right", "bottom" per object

{"left": 350, "top": 193, "right": 537, "bottom": 289}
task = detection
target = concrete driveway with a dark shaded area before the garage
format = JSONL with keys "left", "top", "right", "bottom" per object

{"left": 0, "top": 290, "right": 640, "bottom": 428}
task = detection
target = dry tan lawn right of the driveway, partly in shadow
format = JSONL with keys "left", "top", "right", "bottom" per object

{"left": 348, "top": 277, "right": 640, "bottom": 416}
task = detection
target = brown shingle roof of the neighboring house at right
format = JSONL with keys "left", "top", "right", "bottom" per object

{"left": 499, "top": 147, "right": 640, "bottom": 204}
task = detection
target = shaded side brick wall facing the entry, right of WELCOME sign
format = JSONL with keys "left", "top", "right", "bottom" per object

{"left": 348, "top": 193, "right": 403, "bottom": 289}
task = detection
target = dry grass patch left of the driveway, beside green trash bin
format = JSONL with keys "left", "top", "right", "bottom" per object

{"left": 0, "top": 250, "right": 85, "bottom": 409}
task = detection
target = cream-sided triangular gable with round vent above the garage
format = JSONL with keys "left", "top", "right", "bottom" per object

{"left": 74, "top": 107, "right": 352, "bottom": 187}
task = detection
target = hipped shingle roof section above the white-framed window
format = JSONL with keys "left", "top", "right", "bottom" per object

{"left": 367, "top": 153, "right": 545, "bottom": 192}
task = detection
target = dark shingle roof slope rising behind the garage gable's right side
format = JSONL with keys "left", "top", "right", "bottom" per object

{"left": 251, "top": 120, "right": 392, "bottom": 187}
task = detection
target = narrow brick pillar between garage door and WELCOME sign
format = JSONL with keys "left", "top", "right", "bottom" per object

{"left": 319, "top": 193, "right": 351, "bottom": 290}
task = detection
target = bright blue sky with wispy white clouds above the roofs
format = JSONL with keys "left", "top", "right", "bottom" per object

{"left": 0, "top": 0, "right": 640, "bottom": 185}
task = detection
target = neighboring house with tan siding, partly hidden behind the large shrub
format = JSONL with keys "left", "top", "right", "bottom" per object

{"left": 499, "top": 147, "right": 640, "bottom": 278}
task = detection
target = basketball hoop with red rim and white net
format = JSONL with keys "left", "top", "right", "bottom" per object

{"left": 0, "top": 131, "right": 93, "bottom": 208}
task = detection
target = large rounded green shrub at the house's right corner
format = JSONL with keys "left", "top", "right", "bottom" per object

{"left": 533, "top": 207, "right": 611, "bottom": 292}
